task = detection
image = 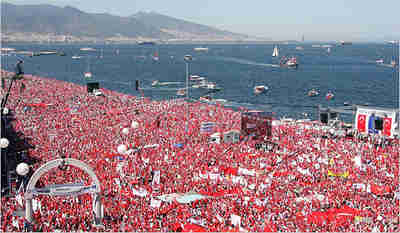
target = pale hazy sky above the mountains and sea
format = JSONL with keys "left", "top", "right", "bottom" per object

{"left": 2, "top": 0, "right": 400, "bottom": 41}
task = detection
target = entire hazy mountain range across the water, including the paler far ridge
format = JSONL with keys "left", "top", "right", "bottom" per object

{"left": 1, "top": 2, "right": 255, "bottom": 41}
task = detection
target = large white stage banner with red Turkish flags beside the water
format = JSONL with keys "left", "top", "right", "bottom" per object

{"left": 354, "top": 106, "right": 396, "bottom": 137}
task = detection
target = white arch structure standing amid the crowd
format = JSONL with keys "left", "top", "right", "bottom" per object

{"left": 25, "top": 158, "right": 102, "bottom": 225}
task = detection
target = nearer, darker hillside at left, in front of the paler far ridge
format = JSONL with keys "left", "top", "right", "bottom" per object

{"left": 1, "top": 3, "right": 168, "bottom": 37}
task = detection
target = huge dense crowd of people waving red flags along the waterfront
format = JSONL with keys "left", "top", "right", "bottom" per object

{"left": 1, "top": 71, "right": 400, "bottom": 232}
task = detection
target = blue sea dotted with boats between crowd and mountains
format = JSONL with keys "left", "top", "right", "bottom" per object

{"left": 1, "top": 43, "right": 399, "bottom": 119}
